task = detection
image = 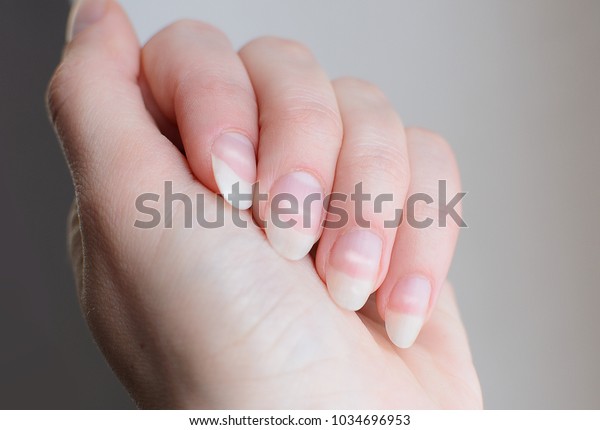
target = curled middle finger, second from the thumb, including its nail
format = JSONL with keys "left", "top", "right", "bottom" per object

{"left": 240, "top": 37, "right": 342, "bottom": 260}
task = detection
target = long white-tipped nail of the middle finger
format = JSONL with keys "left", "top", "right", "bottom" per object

{"left": 266, "top": 171, "right": 323, "bottom": 260}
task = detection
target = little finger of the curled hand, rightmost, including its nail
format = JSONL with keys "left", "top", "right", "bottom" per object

{"left": 377, "top": 129, "right": 462, "bottom": 348}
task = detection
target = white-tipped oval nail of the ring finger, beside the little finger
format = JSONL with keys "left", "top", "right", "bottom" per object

{"left": 325, "top": 230, "right": 383, "bottom": 311}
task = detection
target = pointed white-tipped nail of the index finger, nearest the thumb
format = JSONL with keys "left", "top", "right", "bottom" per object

{"left": 211, "top": 133, "right": 256, "bottom": 209}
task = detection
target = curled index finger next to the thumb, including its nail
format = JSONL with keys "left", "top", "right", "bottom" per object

{"left": 142, "top": 20, "right": 258, "bottom": 209}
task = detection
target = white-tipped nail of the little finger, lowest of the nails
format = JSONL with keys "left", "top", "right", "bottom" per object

{"left": 385, "top": 276, "right": 431, "bottom": 348}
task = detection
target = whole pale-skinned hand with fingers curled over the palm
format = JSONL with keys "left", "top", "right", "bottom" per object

{"left": 48, "top": 0, "right": 482, "bottom": 409}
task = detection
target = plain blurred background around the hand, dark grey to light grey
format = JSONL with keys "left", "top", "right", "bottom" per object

{"left": 0, "top": 0, "right": 600, "bottom": 409}
